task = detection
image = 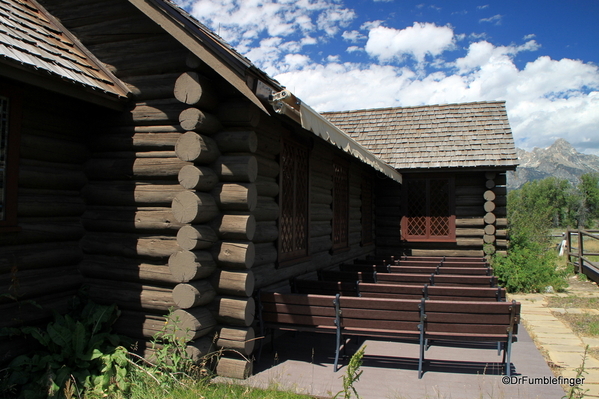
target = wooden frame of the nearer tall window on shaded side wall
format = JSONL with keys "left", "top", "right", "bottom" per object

{"left": 277, "top": 135, "right": 311, "bottom": 267}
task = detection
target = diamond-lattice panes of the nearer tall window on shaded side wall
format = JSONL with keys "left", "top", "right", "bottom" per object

{"left": 279, "top": 141, "right": 309, "bottom": 260}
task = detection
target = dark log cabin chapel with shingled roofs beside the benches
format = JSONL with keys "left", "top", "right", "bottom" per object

{"left": 0, "top": 0, "right": 517, "bottom": 377}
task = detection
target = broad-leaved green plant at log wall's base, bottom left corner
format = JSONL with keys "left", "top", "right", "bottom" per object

{"left": 2, "top": 301, "right": 129, "bottom": 398}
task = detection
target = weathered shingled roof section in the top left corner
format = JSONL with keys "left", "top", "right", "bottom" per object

{"left": 0, "top": 0, "right": 128, "bottom": 98}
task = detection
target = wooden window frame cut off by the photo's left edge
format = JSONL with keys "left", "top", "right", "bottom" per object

{"left": 0, "top": 84, "right": 22, "bottom": 232}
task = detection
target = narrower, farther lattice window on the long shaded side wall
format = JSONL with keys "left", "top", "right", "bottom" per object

{"left": 332, "top": 158, "right": 350, "bottom": 252}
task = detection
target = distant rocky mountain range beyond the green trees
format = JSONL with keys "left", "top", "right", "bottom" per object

{"left": 507, "top": 139, "right": 599, "bottom": 190}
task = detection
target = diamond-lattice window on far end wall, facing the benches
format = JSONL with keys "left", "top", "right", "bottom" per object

{"left": 402, "top": 178, "right": 455, "bottom": 241}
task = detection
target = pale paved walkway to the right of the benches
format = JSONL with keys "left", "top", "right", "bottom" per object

{"left": 510, "top": 279, "right": 599, "bottom": 398}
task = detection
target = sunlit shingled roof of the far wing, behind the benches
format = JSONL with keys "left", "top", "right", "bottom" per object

{"left": 322, "top": 101, "right": 518, "bottom": 171}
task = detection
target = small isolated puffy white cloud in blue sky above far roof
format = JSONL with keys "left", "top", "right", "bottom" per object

{"left": 365, "top": 22, "right": 455, "bottom": 63}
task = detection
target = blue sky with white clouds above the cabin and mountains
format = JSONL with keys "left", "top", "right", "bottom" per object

{"left": 177, "top": 0, "right": 599, "bottom": 155}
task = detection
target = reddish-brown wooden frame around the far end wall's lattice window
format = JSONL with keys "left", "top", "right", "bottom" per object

{"left": 401, "top": 175, "right": 456, "bottom": 242}
